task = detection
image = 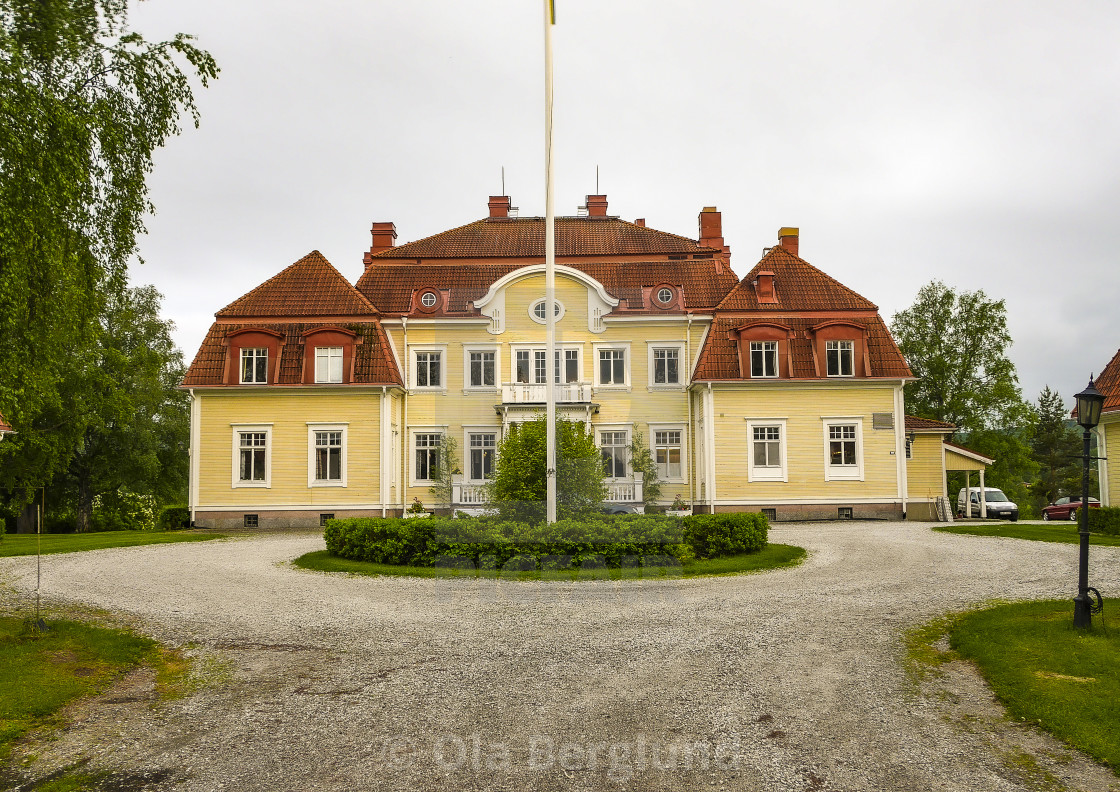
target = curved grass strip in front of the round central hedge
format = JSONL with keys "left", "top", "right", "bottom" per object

{"left": 292, "top": 544, "right": 805, "bottom": 580}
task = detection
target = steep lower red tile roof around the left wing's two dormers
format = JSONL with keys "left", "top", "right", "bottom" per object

{"left": 183, "top": 320, "right": 403, "bottom": 388}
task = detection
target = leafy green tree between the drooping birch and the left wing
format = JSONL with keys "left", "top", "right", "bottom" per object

{"left": 59, "top": 286, "right": 190, "bottom": 531}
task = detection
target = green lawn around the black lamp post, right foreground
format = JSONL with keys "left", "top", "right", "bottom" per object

{"left": 950, "top": 599, "right": 1120, "bottom": 771}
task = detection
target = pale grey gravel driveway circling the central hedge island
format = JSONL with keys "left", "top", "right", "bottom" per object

{"left": 0, "top": 522, "right": 1120, "bottom": 792}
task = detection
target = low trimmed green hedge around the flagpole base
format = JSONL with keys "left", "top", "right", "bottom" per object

{"left": 324, "top": 514, "right": 767, "bottom": 570}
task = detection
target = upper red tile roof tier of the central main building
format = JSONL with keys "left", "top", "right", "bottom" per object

{"left": 372, "top": 217, "right": 719, "bottom": 261}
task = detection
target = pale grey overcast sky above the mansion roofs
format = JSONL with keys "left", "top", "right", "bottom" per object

{"left": 131, "top": 0, "right": 1120, "bottom": 406}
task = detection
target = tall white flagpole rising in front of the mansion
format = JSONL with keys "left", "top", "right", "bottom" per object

{"left": 544, "top": 0, "right": 557, "bottom": 524}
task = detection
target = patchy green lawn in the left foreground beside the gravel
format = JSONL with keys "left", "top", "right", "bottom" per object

{"left": 0, "top": 617, "right": 158, "bottom": 757}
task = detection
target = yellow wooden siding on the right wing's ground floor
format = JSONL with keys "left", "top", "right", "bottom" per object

{"left": 712, "top": 383, "right": 898, "bottom": 502}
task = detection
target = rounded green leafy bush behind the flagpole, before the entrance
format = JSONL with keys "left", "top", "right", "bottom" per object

{"left": 489, "top": 417, "right": 607, "bottom": 522}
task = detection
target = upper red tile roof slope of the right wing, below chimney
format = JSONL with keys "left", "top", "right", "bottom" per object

{"left": 719, "top": 246, "right": 878, "bottom": 311}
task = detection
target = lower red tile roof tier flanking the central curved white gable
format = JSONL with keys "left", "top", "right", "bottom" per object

{"left": 357, "top": 257, "right": 736, "bottom": 314}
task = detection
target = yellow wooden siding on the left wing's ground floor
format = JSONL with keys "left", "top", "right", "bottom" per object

{"left": 196, "top": 389, "right": 381, "bottom": 509}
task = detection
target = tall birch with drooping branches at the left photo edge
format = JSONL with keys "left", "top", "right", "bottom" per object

{"left": 0, "top": 0, "right": 217, "bottom": 490}
